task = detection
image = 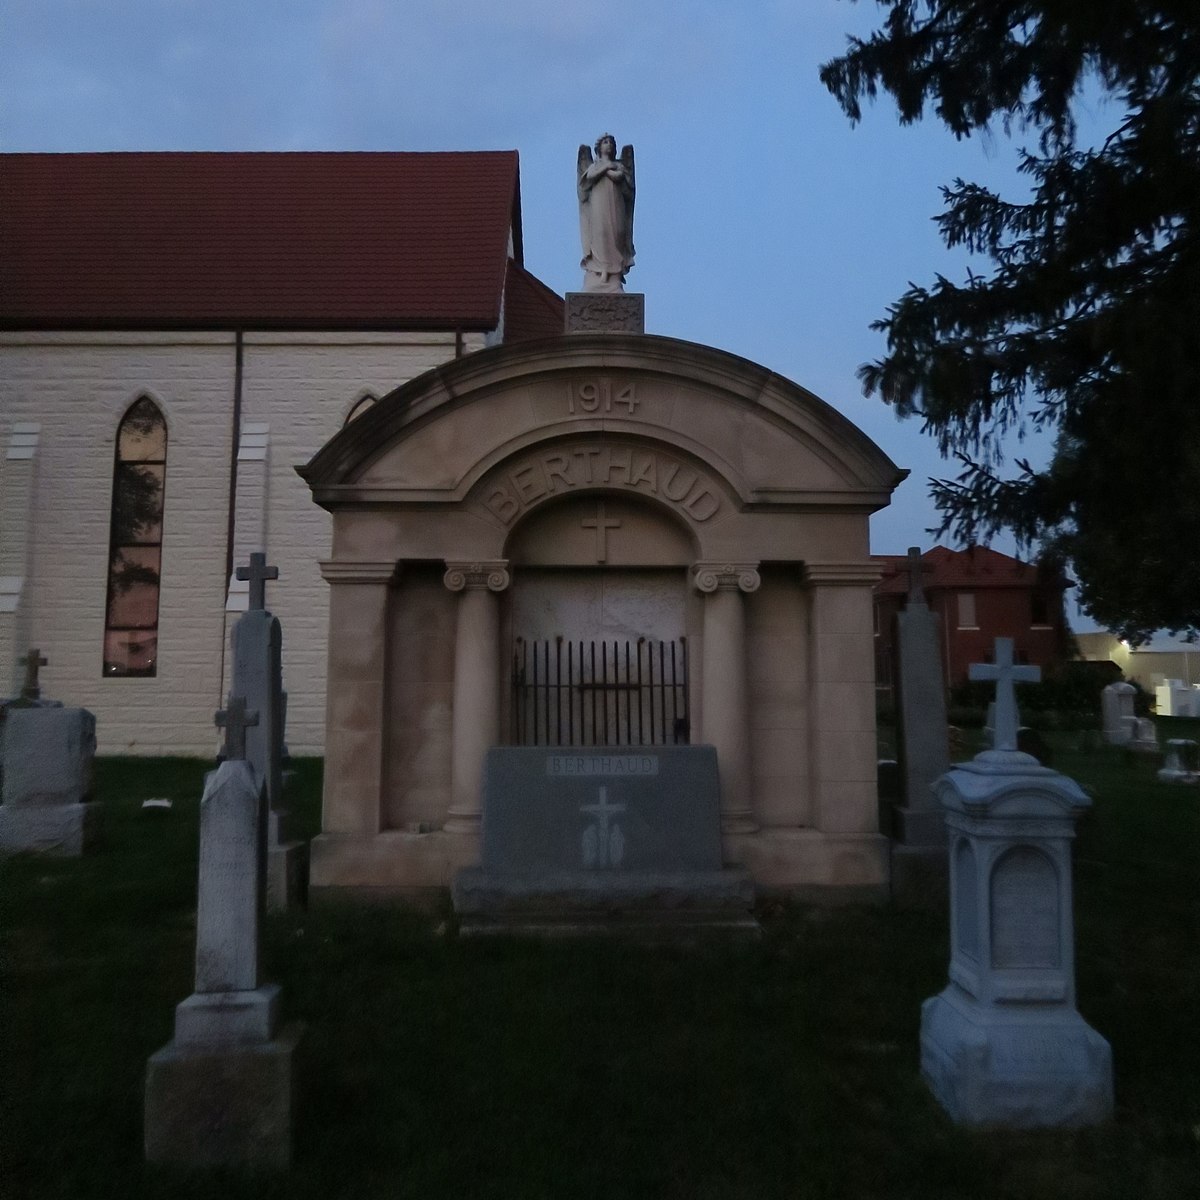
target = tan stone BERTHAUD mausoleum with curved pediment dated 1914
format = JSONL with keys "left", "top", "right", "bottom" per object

{"left": 300, "top": 326, "right": 905, "bottom": 894}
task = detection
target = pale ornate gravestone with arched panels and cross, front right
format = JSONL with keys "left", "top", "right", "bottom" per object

{"left": 920, "top": 638, "right": 1112, "bottom": 1129}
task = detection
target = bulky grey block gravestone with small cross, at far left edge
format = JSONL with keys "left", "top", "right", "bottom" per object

{"left": 0, "top": 649, "right": 101, "bottom": 857}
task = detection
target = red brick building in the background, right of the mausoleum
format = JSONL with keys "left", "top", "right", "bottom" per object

{"left": 875, "top": 546, "right": 1072, "bottom": 695}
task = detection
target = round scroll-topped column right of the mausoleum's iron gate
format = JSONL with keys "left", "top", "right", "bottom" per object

{"left": 692, "top": 563, "right": 762, "bottom": 833}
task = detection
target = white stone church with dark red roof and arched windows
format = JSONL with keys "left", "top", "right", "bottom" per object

{"left": 0, "top": 151, "right": 563, "bottom": 754}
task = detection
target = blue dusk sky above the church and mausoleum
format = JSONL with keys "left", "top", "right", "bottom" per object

{"left": 0, "top": 0, "right": 1103, "bottom": 629}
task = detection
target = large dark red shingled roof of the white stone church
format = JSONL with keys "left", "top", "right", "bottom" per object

{"left": 0, "top": 150, "right": 535, "bottom": 330}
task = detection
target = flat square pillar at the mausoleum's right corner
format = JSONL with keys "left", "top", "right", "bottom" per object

{"left": 804, "top": 562, "right": 880, "bottom": 836}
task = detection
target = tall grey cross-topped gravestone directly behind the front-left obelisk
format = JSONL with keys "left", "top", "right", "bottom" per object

{"left": 232, "top": 552, "right": 307, "bottom": 910}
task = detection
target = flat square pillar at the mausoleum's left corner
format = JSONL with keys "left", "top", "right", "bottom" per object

{"left": 320, "top": 562, "right": 398, "bottom": 834}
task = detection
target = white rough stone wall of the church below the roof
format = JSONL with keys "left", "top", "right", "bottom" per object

{"left": 0, "top": 332, "right": 484, "bottom": 754}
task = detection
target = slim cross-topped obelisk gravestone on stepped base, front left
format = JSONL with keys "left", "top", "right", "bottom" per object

{"left": 145, "top": 698, "right": 300, "bottom": 1168}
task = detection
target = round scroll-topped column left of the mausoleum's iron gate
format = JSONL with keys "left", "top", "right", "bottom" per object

{"left": 443, "top": 559, "right": 511, "bottom": 834}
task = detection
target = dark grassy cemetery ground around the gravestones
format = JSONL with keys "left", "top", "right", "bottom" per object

{"left": 0, "top": 739, "right": 1200, "bottom": 1200}
